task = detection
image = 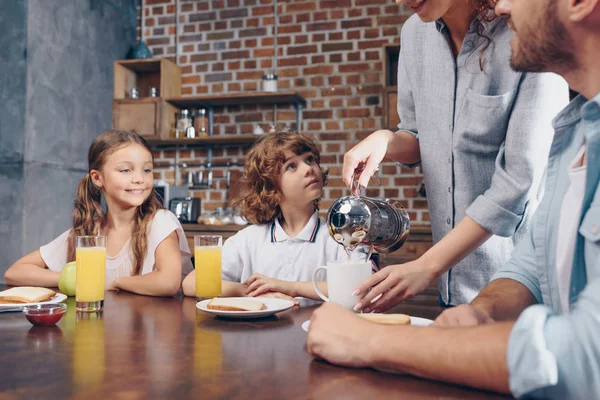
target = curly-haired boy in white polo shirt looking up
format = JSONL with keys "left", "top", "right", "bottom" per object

{"left": 183, "top": 132, "right": 366, "bottom": 299}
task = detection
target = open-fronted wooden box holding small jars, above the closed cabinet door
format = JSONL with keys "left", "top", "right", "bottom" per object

{"left": 113, "top": 58, "right": 181, "bottom": 99}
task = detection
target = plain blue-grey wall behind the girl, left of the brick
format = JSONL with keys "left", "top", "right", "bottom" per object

{"left": 0, "top": 0, "right": 137, "bottom": 280}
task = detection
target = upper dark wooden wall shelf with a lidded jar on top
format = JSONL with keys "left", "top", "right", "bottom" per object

{"left": 166, "top": 91, "right": 306, "bottom": 108}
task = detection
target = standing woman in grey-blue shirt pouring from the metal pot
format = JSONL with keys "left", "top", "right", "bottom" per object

{"left": 342, "top": 0, "right": 568, "bottom": 312}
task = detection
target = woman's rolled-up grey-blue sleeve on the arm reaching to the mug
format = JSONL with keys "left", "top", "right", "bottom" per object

{"left": 466, "top": 73, "right": 568, "bottom": 237}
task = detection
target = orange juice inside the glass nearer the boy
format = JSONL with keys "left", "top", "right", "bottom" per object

{"left": 195, "top": 246, "right": 222, "bottom": 298}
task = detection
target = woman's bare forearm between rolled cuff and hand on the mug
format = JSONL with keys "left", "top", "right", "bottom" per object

{"left": 421, "top": 217, "right": 492, "bottom": 277}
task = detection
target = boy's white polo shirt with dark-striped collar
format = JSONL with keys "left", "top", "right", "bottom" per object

{"left": 222, "top": 212, "right": 367, "bottom": 282}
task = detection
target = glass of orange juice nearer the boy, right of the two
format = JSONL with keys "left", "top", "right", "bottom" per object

{"left": 194, "top": 235, "right": 223, "bottom": 299}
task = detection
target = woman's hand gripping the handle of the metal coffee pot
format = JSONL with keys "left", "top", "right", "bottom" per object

{"left": 342, "top": 129, "right": 394, "bottom": 191}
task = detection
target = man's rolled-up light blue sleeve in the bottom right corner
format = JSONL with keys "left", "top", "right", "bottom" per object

{"left": 507, "top": 279, "right": 600, "bottom": 399}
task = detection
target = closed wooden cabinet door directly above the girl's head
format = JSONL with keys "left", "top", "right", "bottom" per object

{"left": 113, "top": 99, "right": 160, "bottom": 139}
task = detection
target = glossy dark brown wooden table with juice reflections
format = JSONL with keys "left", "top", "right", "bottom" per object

{"left": 0, "top": 285, "right": 502, "bottom": 400}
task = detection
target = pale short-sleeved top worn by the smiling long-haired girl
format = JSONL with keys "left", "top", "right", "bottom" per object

{"left": 40, "top": 210, "right": 193, "bottom": 287}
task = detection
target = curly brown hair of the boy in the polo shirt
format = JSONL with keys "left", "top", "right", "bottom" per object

{"left": 233, "top": 131, "right": 328, "bottom": 224}
